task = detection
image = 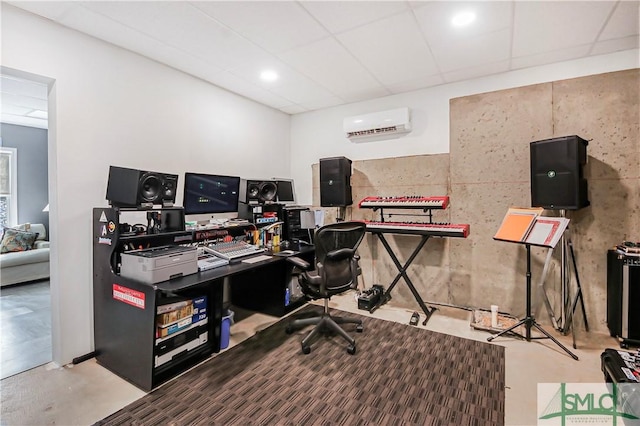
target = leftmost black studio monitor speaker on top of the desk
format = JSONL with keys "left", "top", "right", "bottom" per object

{"left": 106, "top": 166, "right": 178, "bottom": 207}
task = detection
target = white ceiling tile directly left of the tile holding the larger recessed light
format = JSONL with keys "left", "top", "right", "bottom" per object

{"left": 337, "top": 12, "right": 438, "bottom": 85}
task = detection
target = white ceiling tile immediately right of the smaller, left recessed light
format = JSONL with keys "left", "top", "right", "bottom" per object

{"left": 279, "top": 38, "right": 382, "bottom": 97}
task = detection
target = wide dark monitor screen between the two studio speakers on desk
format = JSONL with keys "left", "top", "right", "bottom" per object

{"left": 184, "top": 173, "right": 240, "bottom": 214}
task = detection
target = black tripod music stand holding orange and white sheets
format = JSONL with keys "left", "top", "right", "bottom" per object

{"left": 487, "top": 207, "right": 578, "bottom": 361}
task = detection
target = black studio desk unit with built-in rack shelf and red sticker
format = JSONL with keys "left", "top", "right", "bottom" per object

{"left": 92, "top": 207, "right": 314, "bottom": 391}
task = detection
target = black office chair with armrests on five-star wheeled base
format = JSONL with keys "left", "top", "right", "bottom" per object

{"left": 286, "top": 222, "right": 366, "bottom": 355}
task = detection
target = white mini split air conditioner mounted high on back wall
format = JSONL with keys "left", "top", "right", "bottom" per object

{"left": 344, "top": 108, "right": 411, "bottom": 142}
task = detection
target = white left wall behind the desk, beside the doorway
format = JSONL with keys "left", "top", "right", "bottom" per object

{"left": 1, "top": 3, "right": 290, "bottom": 364}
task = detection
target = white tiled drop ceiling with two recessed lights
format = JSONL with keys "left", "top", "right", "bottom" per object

{"left": 1, "top": 1, "right": 640, "bottom": 122}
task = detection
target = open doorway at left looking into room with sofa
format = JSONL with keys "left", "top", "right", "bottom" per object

{"left": 0, "top": 67, "right": 53, "bottom": 379}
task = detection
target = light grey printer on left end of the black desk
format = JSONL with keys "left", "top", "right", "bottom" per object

{"left": 120, "top": 245, "right": 198, "bottom": 284}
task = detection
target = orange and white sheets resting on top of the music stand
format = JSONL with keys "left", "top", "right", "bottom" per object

{"left": 493, "top": 207, "right": 569, "bottom": 248}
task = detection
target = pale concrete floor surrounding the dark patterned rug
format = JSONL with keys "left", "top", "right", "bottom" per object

{"left": 0, "top": 293, "right": 618, "bottom": 426}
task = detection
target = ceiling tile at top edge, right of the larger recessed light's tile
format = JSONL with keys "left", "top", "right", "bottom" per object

{"left": 513, "top": 1, "right": 615, "bottom": 57}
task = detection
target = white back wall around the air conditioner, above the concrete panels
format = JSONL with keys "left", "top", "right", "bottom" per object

{"left": 291, "top": 49, "right": 640, "bottom": 205}
